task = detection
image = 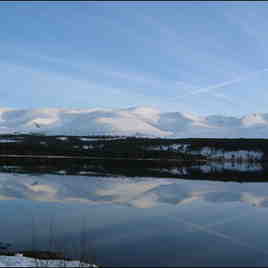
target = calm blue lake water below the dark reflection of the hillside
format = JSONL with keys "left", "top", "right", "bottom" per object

{"left": 0, "top": 168, "right": 268, "bottom": 267}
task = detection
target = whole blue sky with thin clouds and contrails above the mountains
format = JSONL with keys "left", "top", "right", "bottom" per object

{"left": 0, "top": 1, "right": 268, "bottom": 116}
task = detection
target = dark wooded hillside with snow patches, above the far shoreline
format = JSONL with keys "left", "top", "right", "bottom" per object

{"left": 0, "top": 135, "right": 268, "bottom": 161}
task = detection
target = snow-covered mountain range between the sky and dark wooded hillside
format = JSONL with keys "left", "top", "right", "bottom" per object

{"left": 0, "top": 107, "right": 268, "bottom": 138}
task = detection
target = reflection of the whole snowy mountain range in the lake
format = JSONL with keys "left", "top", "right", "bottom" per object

{"left": 0, "top": 173, "right": 268, "bottom": 208}
